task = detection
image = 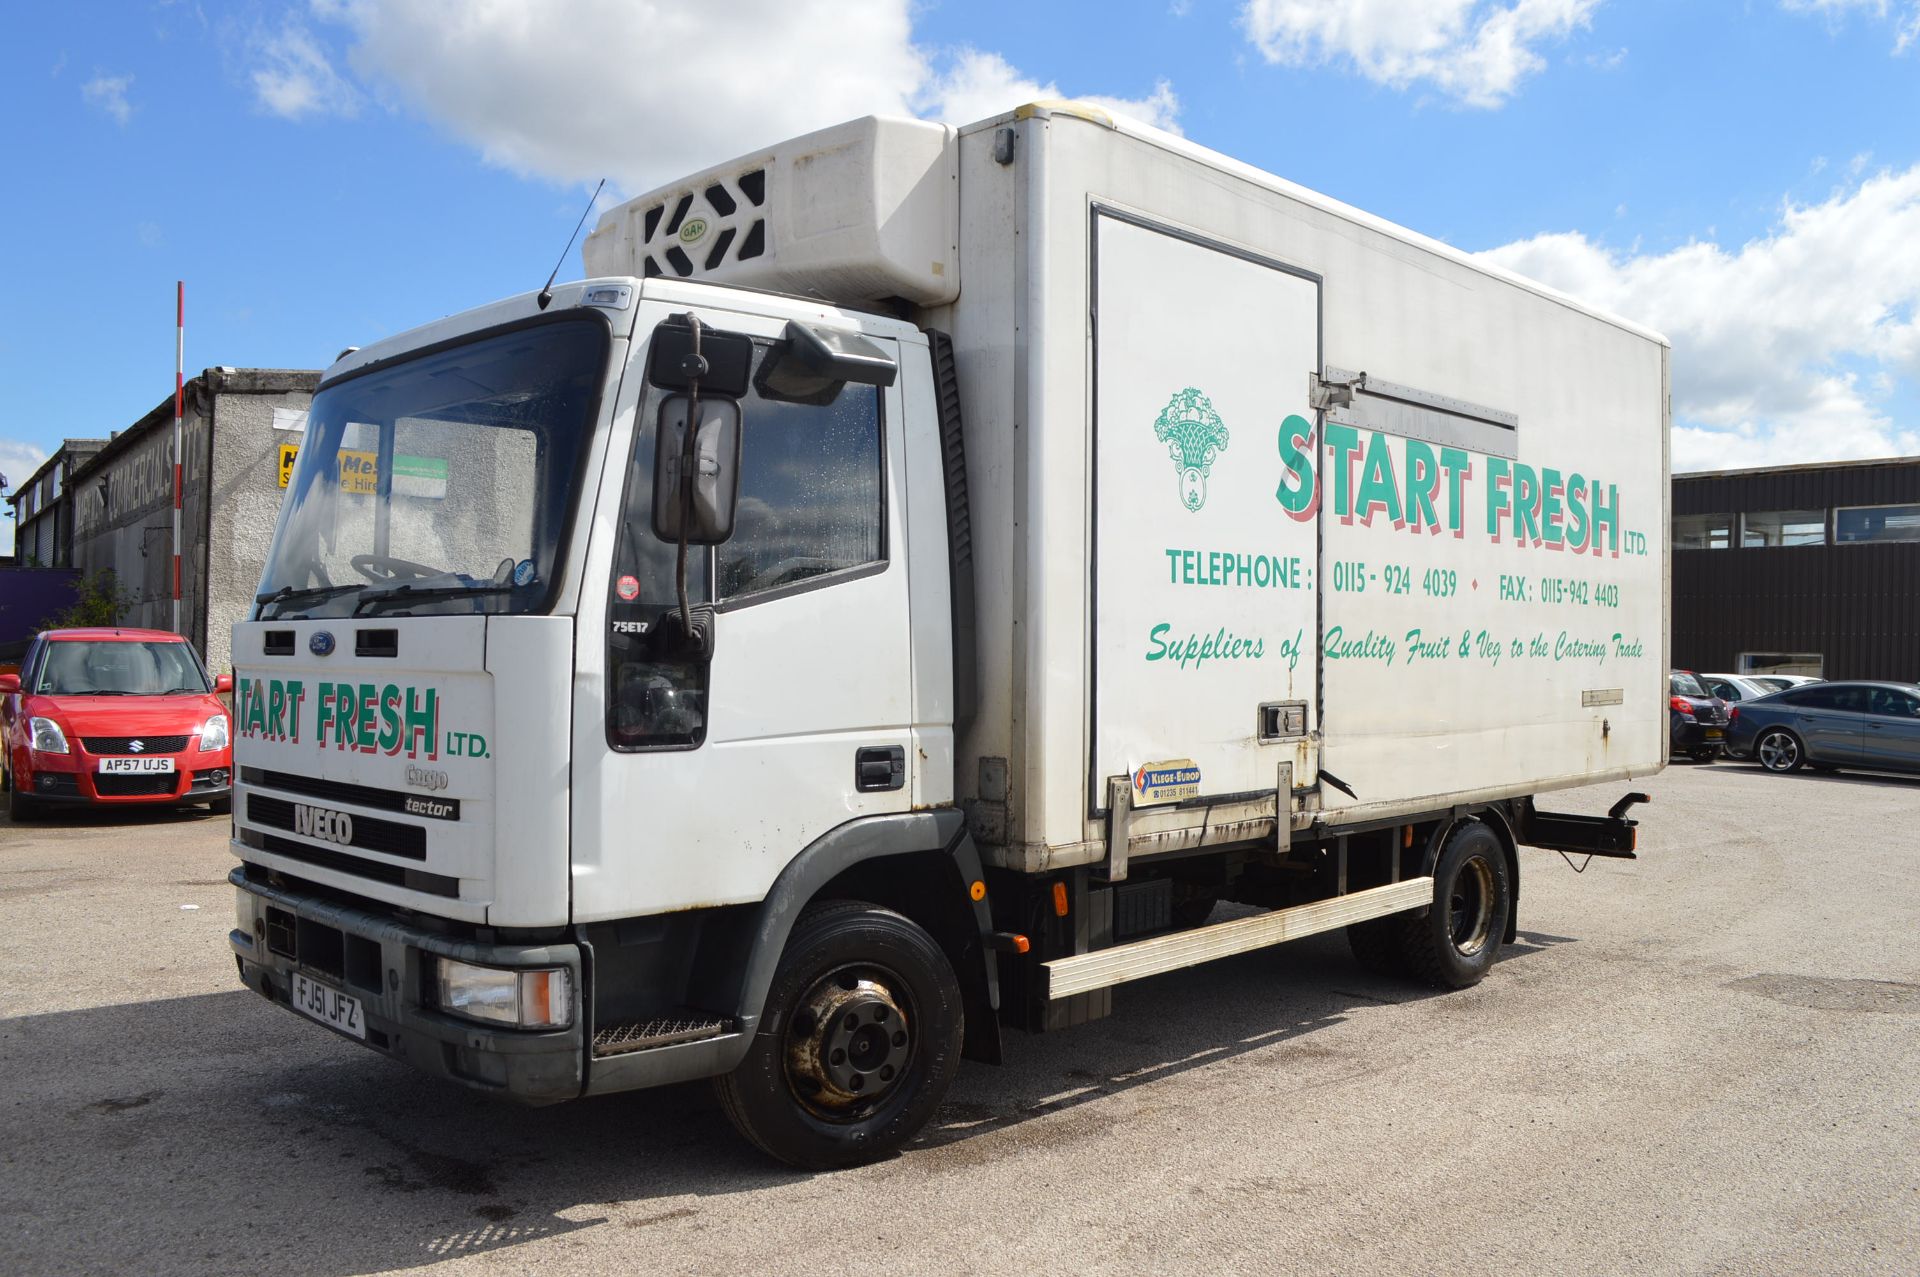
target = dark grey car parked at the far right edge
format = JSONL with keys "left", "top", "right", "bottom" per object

{"left": 1728, "top": 682, "right": 1920, "bottom": 774}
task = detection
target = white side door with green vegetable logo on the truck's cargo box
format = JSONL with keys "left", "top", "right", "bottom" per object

{"left": 1089, "top": 207, "right": 1321, "bottom": 814}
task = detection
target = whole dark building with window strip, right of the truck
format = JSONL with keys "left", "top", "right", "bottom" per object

{"left": 1672, "top": 457, "right": 1920, "bottom": 682}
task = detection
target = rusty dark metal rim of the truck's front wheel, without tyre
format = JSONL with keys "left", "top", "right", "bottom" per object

{"left": 787, "top": 964, "right": 914, "bottom": 1121}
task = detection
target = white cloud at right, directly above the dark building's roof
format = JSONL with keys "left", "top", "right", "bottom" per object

{"left": 1480, "top": 165, "right": 1920, "bottom": 470}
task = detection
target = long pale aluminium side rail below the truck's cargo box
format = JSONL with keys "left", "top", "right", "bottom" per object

{"left": 1044, "top": 878, "right": 1434, "bottom": 1000}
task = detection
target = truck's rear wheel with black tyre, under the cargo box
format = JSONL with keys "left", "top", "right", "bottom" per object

{"left": 1394, "top": 820, "right": 1513, "bottom": 989}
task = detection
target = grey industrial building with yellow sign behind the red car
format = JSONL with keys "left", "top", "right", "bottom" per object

{"left": 63, "top": 369, "right": 321, "bottom": 672}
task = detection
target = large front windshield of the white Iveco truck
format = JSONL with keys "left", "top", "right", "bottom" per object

{"left": 253, "top": 317, "right": 609, "bottom": 620}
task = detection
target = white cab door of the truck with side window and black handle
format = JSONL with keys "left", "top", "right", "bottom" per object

{"left": 574, "top": 305, "right": 916, "bottom": 922}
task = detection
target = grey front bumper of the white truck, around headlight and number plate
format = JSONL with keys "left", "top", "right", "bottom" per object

{"left": 228, "top": 866, "right": 586, "bottom": 1104}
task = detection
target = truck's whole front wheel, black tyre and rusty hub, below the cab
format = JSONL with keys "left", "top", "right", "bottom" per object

{"left": 716, "top": 901, "right": 966, "bottom": 1171}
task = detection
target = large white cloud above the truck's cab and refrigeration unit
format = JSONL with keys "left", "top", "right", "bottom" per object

{"left": 282, "top": 0, "right": 1179, "bottom": 192}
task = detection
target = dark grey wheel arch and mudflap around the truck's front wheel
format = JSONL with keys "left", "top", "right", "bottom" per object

{"left": 737, "top": 808, "right": 1000, "bottom": 1064}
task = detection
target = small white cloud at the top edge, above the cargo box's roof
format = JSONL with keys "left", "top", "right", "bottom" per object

{"left": 1240, "top": 0, "right": 1601, "bottom": 108}
